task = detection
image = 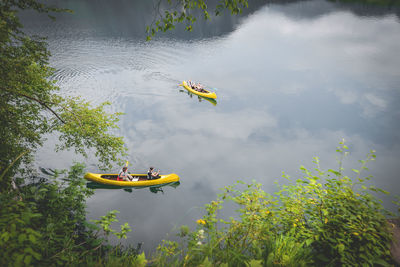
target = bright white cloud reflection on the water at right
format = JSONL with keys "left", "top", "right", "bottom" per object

{"left": 105, "top": 8, "right": 400, "bottom": 253}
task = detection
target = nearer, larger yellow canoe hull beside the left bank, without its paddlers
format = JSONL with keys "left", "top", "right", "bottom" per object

{"left": 84, "top": 172, "right": 179, "bottom": 187}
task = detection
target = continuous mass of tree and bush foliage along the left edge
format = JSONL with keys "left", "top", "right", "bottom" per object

{"left": 0, "top": 0, "right": 137, "bottom": 266}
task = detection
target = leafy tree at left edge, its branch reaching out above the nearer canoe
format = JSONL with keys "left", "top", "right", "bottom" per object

{"left": 0, "top": 0, "right": 124, "bottom": 193}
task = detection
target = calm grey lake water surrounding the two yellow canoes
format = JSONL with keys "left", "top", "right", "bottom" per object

{"left": 24, "top": 0, "right": 400, "bottom": 253}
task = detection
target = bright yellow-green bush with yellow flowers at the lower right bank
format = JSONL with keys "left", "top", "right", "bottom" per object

{"left": 152, "top": 142, "right": 392, "bottom": 266}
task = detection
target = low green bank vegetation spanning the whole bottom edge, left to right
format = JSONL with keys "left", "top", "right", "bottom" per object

{"left": 0, "top": 144, "right": 398, "bottom": 266}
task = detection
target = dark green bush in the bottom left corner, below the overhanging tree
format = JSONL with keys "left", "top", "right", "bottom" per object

{"left": 0, "top": 164, "right": 146, "bottom": 266}
